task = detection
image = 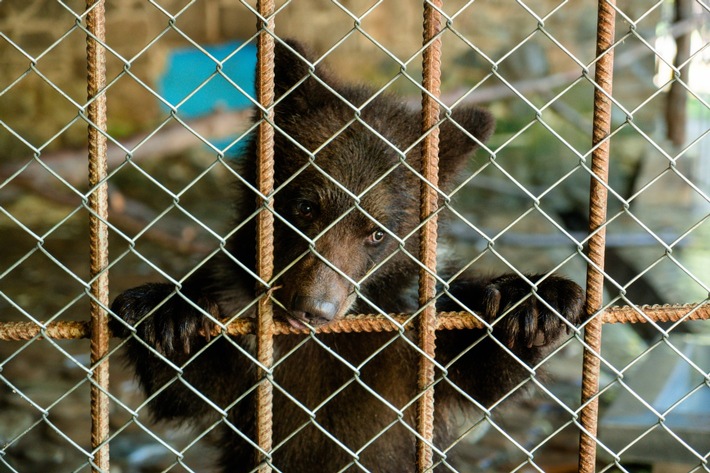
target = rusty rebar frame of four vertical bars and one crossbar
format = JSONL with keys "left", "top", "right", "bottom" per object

{"left": 0, "top": 0, "right": 710, "bottom": 473}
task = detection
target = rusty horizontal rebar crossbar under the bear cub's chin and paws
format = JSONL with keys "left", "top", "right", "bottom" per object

{"left": 0, "top": 304, "right": 710, "bottom": 341}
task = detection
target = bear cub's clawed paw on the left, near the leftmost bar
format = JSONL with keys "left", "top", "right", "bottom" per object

{"left": 109, "top": 284, "right": 218, "bottom": 359}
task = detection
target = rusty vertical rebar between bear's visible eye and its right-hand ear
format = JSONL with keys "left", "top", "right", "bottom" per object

{"left": 417, "top": 0, "right": 442, "bottom": 471}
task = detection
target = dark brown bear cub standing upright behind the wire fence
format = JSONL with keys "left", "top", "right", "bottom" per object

{"left": 111, "top": 40, "right": 583, "bottom": 473}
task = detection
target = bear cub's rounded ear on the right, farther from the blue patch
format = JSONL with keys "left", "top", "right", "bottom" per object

{"left": 439, "top": 105, "right": 495, "bottom": 187}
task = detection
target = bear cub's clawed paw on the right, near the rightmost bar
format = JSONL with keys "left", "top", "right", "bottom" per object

{"left": 484, "top": 275, "right": 584, "bottom": 348}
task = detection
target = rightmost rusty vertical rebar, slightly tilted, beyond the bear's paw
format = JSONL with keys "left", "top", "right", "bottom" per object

{"left": 579, "top": 0, "right": 616, "bottom": 473}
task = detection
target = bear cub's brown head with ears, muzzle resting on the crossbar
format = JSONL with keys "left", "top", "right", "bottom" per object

{"left": 245, "top": 40, "right": 494, "bottom": 327}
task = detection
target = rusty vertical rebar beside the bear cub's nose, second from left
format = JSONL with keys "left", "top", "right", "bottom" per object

{"left": 256, "top": 0, "right": 275, "bottom": 473}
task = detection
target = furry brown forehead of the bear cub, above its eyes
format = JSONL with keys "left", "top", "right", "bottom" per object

{"left": 275, "top": 93, "right": 418, "bottom": 197}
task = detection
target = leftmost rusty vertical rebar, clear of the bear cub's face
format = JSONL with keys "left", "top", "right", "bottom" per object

{"left": 86, "top": 0, "right": 109, "bottom": 473}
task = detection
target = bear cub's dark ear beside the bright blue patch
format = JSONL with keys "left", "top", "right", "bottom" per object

{"left": 274, "top": 39, "right": 331, "bottom": 114}
